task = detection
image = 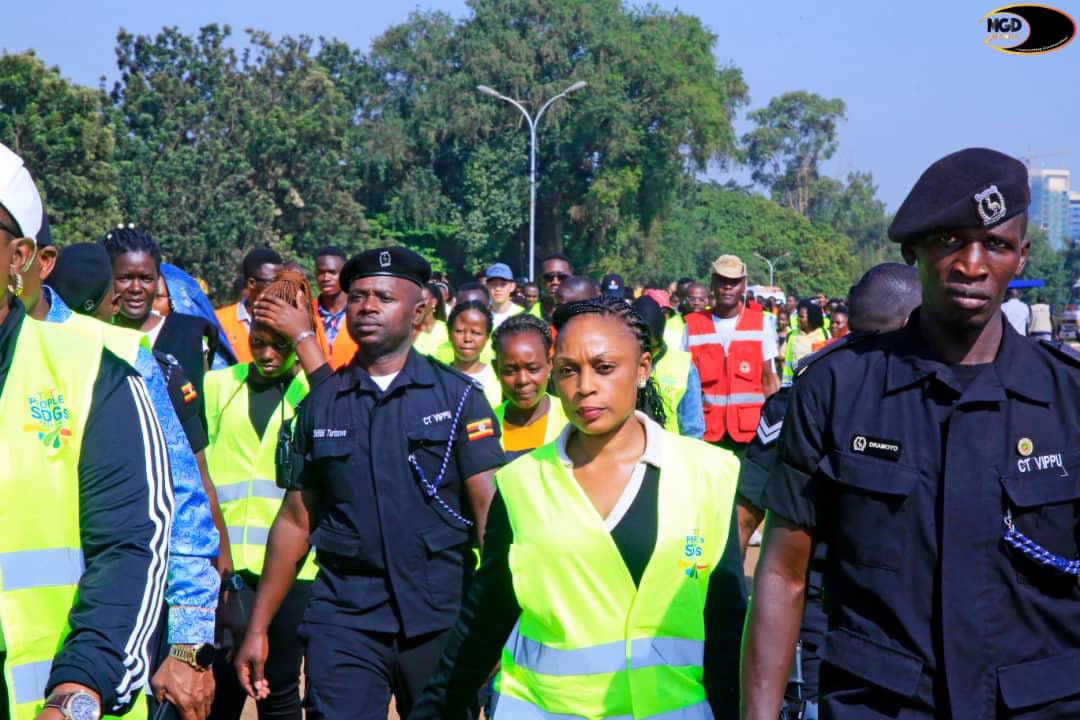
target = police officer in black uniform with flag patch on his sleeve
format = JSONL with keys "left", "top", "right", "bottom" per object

{"left": 237, "top": 247, "right": 503, "bottom": 720}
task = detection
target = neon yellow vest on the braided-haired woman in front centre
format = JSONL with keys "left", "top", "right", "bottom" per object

{"left": 495, "top": 432, "right": 739, "bottom": 720}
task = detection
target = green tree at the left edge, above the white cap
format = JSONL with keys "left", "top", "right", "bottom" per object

{"left": 0, "top": 52, "right": 120, "bottom": 244}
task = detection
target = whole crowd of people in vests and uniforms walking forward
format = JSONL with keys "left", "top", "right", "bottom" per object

{"left": 0, "top": 138, "right": 1080, "bottom": 720}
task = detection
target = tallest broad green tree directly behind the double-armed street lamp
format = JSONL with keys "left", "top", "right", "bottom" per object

{"left": 364, "top": 0, "right": 746, "bottom": 276}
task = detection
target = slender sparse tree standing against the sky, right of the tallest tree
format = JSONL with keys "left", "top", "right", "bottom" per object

{"left": 742, "top": 91, "right": 845, "bottom": 215}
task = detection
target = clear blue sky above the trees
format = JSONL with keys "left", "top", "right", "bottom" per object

{"left": 0, "top": 0, "right": 1080, "bottom": 209}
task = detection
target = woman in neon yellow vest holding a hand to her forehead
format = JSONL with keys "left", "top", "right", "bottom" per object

{"left": 205, "top": 270, "right": 330, "bottom": 720}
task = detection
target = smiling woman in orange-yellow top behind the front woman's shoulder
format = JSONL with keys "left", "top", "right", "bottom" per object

{"left": 491, "top": 314, "right": 566, "bottom": 460}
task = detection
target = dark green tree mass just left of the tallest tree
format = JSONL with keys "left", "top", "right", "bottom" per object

{"left": 112, "top": 25, "right": 370, "bottom": 299}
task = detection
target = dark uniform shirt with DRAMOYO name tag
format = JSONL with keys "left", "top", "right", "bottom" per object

{"left": 762, "top": 312, "right": 1080, "bottom": 720}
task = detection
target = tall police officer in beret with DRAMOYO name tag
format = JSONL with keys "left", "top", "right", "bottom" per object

{"left": 742, "top": 149, "right": 1080, "bottom": 720}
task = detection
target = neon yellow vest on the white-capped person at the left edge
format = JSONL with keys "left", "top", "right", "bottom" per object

{"left": 0, "top": 317, "right": 102, "bottom": 720}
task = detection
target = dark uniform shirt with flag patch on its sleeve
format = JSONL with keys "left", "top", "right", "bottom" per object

{"left": 292, "top": 351, "right": 503, "bottom": 637}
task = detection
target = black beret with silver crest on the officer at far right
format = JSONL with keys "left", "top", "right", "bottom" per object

{"left": 889, "top": 148, "right": 1031, "bottom": 243}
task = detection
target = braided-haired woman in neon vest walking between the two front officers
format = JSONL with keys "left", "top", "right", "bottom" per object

{"left": 409, "top": 298, "right": 745, "bottom": 720}
